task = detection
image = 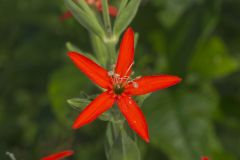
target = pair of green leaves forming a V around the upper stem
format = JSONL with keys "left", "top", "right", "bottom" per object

{"left": 65, "top": 0, "right": 141, "bottom": 39}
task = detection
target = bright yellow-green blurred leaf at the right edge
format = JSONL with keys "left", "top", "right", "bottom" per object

{"left": 190, "top": 37, "right": 238, "bottom": 79}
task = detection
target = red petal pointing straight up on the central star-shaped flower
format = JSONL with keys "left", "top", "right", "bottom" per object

{"left": 115, "top": 28, "right": 134, "bottom": 77}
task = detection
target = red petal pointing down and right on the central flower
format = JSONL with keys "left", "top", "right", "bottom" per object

{"left": 118, "top": 96, "right": 149, "bottom": 142}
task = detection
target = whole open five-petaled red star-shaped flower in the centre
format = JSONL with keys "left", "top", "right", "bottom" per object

{"left": 68, "top": 28, "right": 181, "bottom": 142}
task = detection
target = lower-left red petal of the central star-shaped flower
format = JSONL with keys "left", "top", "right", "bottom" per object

{"left": 73, "top": 92, "right": 115, "bottom": 129}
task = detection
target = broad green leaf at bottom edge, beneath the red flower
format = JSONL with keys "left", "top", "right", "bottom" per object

{"left": 105, "top": 123, "right": 141, "bottom": 160}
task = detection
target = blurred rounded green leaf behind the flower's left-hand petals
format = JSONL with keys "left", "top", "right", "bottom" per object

{"left": 48, "top": 64, "right": 90, "bottom": 125}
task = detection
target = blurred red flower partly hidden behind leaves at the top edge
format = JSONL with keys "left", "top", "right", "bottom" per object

{"left": 60, "top": 0, "right": 118, "bottom": 20}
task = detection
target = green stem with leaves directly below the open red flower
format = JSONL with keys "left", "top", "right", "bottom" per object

{"left": 105, "top": 105, "right": 141, "bottom": 160}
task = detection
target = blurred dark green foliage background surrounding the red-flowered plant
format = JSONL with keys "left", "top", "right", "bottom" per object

{"left": 0, "top": 0, "right": 240, "bottom": 160}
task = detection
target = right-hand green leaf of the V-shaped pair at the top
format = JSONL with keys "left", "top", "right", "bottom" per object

{"left": 113, "top": 0, "right": 141, "bottom": 36}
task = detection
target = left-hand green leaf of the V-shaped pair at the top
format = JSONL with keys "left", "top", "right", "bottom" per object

{"left": 64, "top": 0, "right": 105, "bottom": 38}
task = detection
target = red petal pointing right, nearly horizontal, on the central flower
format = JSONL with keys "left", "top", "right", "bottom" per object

{"left": 126, "top": 75, "right": 181, "bottom": 95}
